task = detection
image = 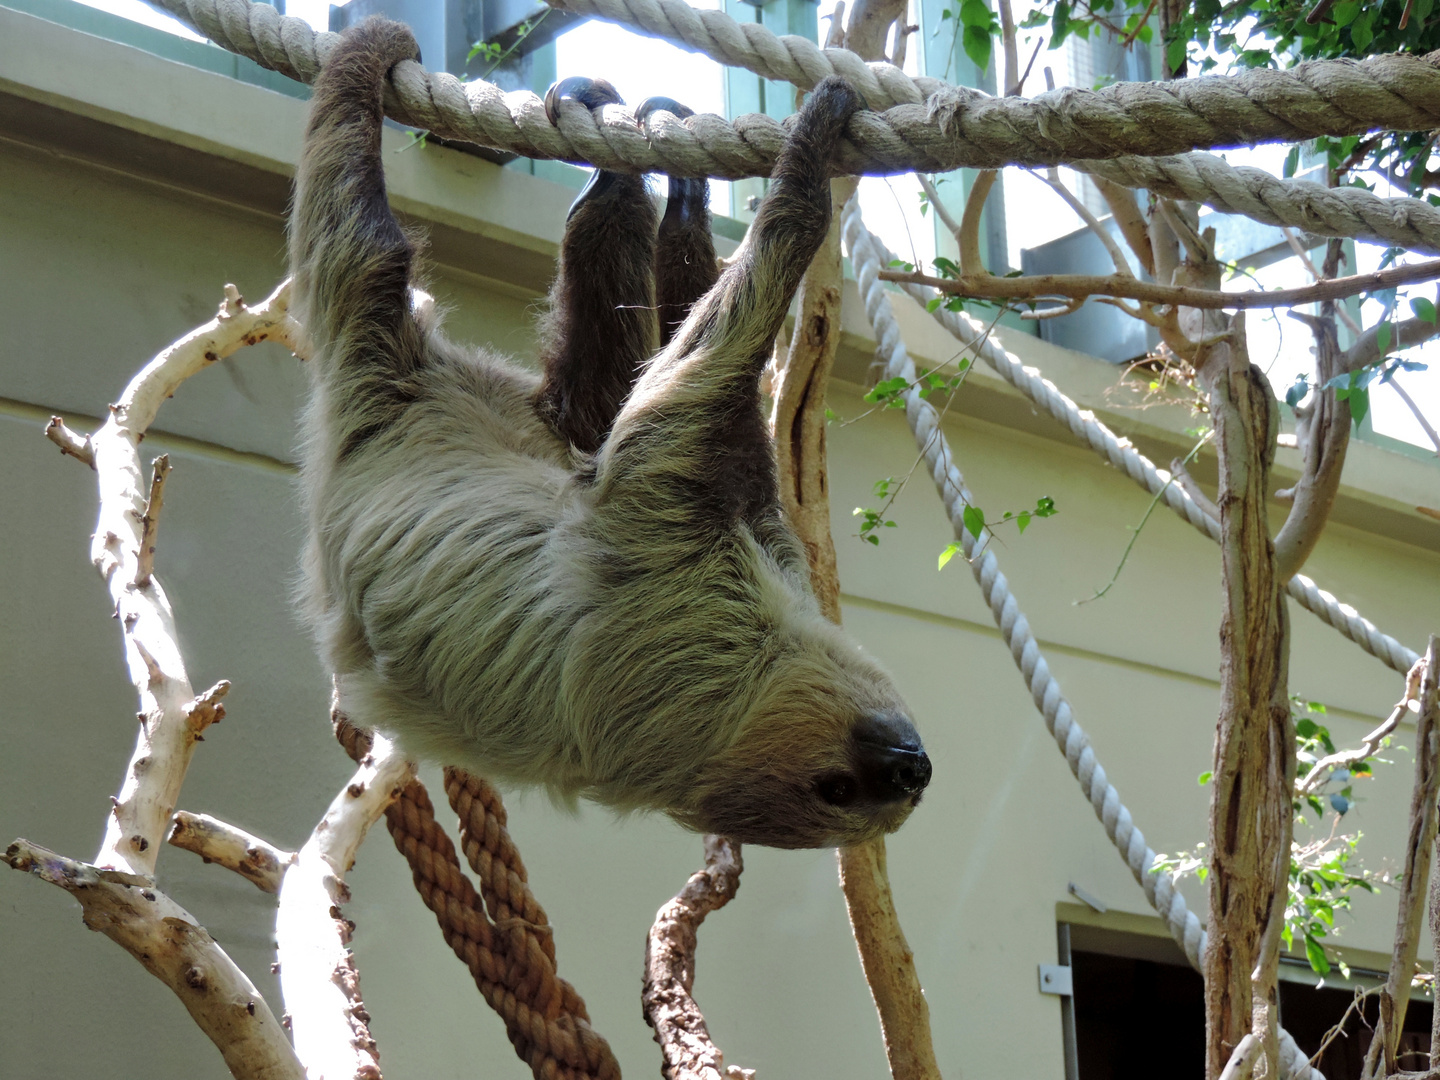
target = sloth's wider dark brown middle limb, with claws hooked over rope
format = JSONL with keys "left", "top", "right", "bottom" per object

{"left": 537, "top": 78, "right": 657, "bottom": 452}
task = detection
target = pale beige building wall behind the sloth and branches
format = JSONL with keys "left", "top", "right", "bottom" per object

{"left": 0, "top": 9, "right": 1440, "bottom": 1080}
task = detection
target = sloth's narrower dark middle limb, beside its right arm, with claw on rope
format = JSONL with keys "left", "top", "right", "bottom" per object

{"left": 635, "top": 98, "right": 720, "bottom": 348}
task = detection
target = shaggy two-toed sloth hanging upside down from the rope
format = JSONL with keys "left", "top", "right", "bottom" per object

{"left": 289, "top": 12, "right": 930, "bottom": 848}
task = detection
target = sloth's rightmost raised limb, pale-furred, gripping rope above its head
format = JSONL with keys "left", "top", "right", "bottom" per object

{"left": 598, "top": 78, "right": 860, "bottom": 544}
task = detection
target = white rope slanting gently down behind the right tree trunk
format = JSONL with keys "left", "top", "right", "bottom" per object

{"left": 852, "top": 228, "right": 1420, "bottom": 672}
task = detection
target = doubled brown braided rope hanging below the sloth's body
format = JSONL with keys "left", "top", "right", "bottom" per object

{"left": 336, "top": 717, "right": 621, "bottom": 1080}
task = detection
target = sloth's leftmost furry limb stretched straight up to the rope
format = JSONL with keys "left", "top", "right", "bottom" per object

{"left": 289, "top": 19, "right": 423, "bottom": 456}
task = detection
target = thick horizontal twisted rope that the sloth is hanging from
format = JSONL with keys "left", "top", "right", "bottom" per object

{"left": 151, "top": 0, "right": 1440, "bottom": 179}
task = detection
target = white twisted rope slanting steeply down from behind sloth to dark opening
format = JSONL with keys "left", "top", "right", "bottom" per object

{"left": 842, "top": 199, "right": 1325, "bottom": 1080}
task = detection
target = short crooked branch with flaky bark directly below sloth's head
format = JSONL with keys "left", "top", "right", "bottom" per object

{"left": 641, "top": 837, "right": 755, "bottom": 1080}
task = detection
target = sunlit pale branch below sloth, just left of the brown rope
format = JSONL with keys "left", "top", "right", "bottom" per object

{"left": 275, "top": 722, "right": 415, "bottom": 1080}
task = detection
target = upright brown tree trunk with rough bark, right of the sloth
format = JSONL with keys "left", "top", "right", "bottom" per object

{"left": 1198, "top": 312, "right": 1295, "bottom": 1080}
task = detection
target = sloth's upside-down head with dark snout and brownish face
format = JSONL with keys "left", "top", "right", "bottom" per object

{"left": 675, "top": 619, "right": 930, "bottom": 848}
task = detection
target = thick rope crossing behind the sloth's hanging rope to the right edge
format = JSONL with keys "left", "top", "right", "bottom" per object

{"left": 549, "top": 0, "right": 1440, "bottom": 255}
